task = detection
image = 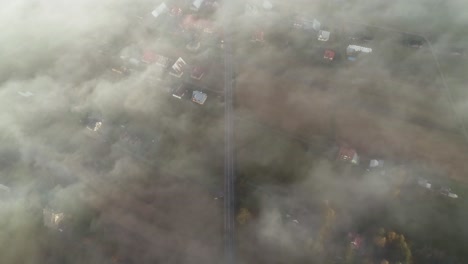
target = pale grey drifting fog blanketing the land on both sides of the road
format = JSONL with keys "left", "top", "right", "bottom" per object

{"left": 0, "top": 0, "right": 468, "bottom": 264}
